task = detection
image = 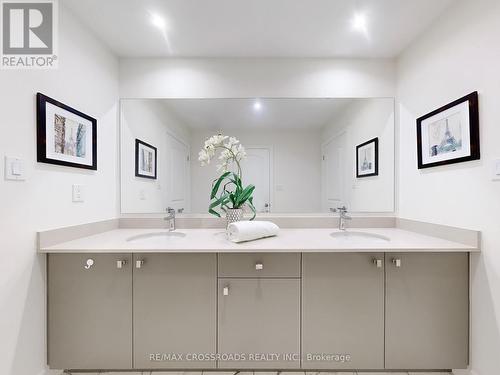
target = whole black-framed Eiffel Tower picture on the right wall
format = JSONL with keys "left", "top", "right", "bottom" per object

{"left": 417, "top": 92, "right": 480, "bottom": 169}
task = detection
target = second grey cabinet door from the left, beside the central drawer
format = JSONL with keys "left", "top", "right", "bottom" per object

{"left": 133, "top": 254, "right": 217, "bottom": 369}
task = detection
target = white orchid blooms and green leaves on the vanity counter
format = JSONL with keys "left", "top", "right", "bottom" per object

{"left": 198, "top": 134, "right": 255, "bottom": 220}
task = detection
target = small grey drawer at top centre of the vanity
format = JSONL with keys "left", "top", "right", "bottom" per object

{"left": 219, "top": 253, "right": 301, "bottom": 277}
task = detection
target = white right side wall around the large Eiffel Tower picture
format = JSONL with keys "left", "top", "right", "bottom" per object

{"left": 398, "top": 0, "right": 500, "bottom": 375}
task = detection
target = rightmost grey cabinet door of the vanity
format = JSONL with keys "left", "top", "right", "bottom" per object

{"left": 386, "top": 253, "right": 469, "bottom": 369}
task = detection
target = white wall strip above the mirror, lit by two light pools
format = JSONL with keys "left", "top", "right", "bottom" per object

{"left": 120, "top": 59, "right": 395, "bottom": 98}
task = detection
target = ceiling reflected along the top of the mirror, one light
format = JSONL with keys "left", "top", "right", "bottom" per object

{"left": 159, "top": 99, "right": 356, "bottom": 131}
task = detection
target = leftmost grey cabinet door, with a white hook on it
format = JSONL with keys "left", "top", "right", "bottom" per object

{"left": 47, "top": 254, "right": 132, "bottom": 369}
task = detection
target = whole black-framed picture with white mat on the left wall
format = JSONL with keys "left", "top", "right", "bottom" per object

{"left": 36, "top": 93, "right": 97, "bottom": 170}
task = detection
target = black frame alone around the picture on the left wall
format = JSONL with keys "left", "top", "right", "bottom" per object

{"left": 36, "top": 93, "right": 97, "bottom": 170}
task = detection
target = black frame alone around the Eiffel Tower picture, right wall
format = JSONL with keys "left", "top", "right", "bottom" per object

{"left": 417, "top": 91, "right": 481, "bottom": 169}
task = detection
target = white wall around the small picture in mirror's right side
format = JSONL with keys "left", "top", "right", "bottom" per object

{"left": 322, "top": 98, "right": 395, "bottom": 212}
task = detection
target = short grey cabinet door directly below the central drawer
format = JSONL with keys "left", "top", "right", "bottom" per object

{"left": 218, "top": 279, "right": 300, "bottom": 369}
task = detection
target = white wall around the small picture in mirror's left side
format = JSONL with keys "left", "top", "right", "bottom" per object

{"left": 120, "top": 99, "right": 190, "bottom": 213}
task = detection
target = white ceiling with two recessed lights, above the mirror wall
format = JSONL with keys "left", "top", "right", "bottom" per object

{"left": 64, "top": 0, "right": 455, "bottom": 58}
